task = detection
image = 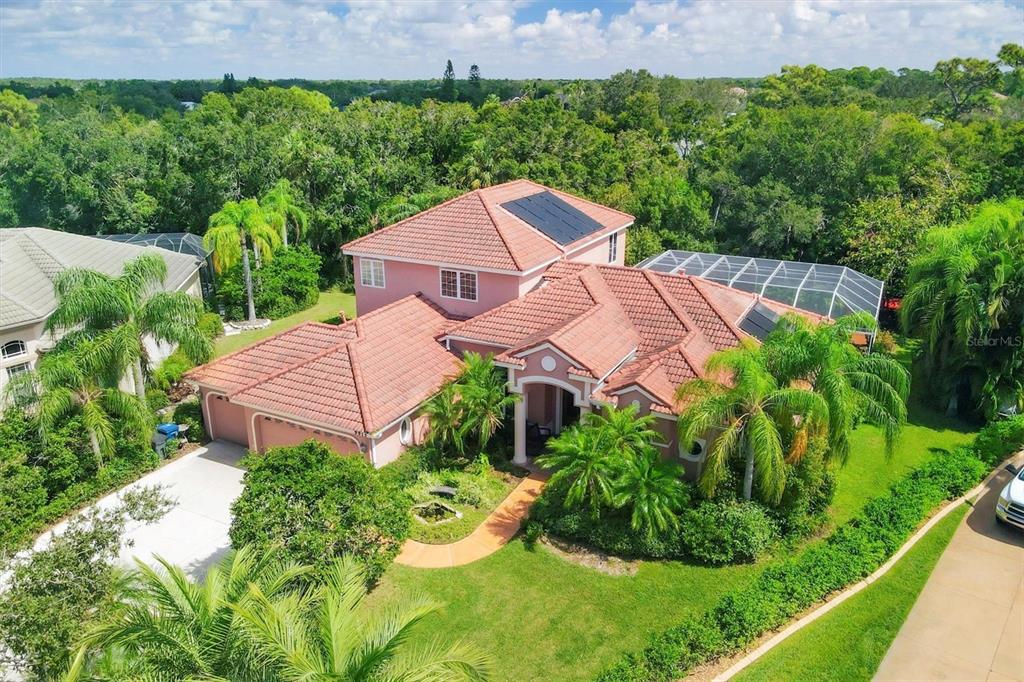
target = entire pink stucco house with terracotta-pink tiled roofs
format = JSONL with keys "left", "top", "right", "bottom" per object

{"left": 188, "top": 180, "right": 815, "bottom": 476}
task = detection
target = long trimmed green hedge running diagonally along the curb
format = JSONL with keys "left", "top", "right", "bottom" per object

{"left": 598, "top": 419, "right": 1024, "bottom": 682}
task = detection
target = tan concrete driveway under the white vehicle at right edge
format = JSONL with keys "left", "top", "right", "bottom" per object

{"left": 874, "top": 454, "right": 1024, "bottom": 681}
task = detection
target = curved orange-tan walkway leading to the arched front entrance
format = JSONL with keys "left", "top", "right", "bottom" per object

{"left": 395, "top": 466, "right": 547, "bottom": 568}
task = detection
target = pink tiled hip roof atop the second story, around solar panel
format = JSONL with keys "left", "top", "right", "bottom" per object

{"left": 342, "top": 180, "right": 633, "bottom": 272}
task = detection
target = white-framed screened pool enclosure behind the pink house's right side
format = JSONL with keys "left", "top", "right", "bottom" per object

{"left": 637, "top": 251, "right": 885, "bottom": 319}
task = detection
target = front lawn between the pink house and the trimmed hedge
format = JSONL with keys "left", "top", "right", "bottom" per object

{"left": 371, "top": 401, "right": 972, "bottom": 680}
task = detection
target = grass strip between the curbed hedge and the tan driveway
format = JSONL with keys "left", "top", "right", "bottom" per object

{"left": 732, "top": 505, "right": 968, "bottom": 682}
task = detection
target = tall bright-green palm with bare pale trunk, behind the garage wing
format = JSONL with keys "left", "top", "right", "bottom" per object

{"left": 203, "top": 199, "right": 281, "bottom": 323}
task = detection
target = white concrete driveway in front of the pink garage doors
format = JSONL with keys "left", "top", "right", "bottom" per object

{"left": 36, "top": 440, "right": 245, "bottom": 578}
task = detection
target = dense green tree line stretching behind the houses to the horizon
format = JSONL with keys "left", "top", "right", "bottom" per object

{"left": 0, "top": 45, "right": 1024, "bottom": 286}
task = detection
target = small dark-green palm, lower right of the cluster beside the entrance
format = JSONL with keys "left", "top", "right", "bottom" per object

{"left": 614, "top": 445, "right": 686, "bottom": 537}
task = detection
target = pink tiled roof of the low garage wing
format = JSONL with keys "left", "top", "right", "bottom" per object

{"left": 187, "top": 294, "right": 462, "bottom": 434}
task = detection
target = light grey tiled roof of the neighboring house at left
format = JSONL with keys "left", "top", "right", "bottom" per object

{"left": 0, "top": 227, "right": 201, "bottom": 329}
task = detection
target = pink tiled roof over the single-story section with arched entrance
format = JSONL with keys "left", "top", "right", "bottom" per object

{"left": 449, "top": 261, "right": 814, "bottom": 413}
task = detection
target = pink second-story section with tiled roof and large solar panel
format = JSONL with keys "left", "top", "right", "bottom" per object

{"left": 342, "top": 180, "right": 633, "bottom": 316}
